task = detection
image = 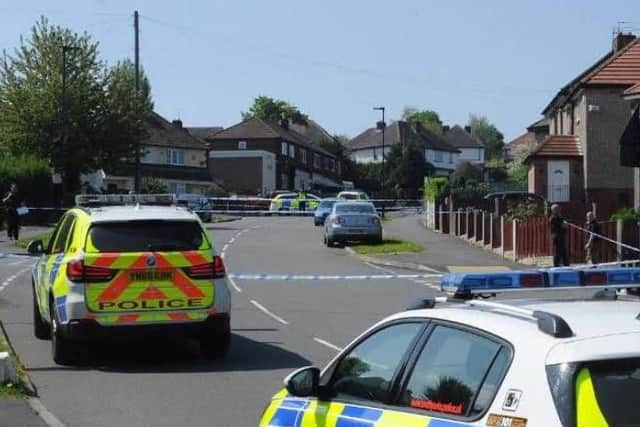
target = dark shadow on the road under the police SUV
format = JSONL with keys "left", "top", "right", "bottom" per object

{"left": 27, "top": 334, "right": 312, "bottom": 373}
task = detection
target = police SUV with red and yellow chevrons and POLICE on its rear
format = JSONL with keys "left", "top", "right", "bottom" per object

{"left": 28, "top": 195, "right": 231, "bottom": 364}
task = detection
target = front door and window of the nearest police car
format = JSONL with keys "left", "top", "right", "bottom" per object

{"left": 267, "top": 321, "right": 426, "bottom": 427}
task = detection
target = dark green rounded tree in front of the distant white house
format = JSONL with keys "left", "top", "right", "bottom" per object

{"left": 385, "top": 144, "right": 433, "bottom": 192}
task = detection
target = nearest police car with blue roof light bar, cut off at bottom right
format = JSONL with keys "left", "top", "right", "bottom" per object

{"left": 260, "top": 269, "right": 640, "bottom": 427}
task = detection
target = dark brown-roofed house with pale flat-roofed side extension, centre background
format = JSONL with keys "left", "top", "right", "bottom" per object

{"left": 207, "top": 117, "right": 342, "bottom": 195}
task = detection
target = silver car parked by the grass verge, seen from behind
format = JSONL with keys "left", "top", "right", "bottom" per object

{"left": 324, "top": 202, "right": 382, "bottom": 246}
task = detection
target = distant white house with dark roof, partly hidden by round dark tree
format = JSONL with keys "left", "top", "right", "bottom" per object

{"left": 349, "top": 120, "right": 460, "bottom": 175}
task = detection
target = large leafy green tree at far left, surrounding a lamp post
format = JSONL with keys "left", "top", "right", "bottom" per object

{"left": 0, "top": 17, "right": 151, "bottom": 193}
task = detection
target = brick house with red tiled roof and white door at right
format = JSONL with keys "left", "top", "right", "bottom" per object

{"left": 528, "top": 34, "right": 640, "bottom": 218}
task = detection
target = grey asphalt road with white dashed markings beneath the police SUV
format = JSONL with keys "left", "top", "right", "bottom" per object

{"left": 0, "top": 218, "right": 480, "bottom": 427}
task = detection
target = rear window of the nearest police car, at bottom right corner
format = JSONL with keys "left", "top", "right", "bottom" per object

{"left": 578, "top": 358, "right": 640, "bottom": 427}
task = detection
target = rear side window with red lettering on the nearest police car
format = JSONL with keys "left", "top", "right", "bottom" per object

{"left": 392, "top": 322, "right": 512, "bottom": 427}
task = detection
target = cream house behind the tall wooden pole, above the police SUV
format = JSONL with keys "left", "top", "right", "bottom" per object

{"left": 103, "top": 113, "right": 214, "bottom": 194}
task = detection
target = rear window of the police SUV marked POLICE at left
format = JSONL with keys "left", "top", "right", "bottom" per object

{"left": 87, "top": 220, "right": 211, "bottom": 252}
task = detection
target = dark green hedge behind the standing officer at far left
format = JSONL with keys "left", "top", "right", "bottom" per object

{"left": 0, "top": 153, "right": 54, "bottom": 226}
